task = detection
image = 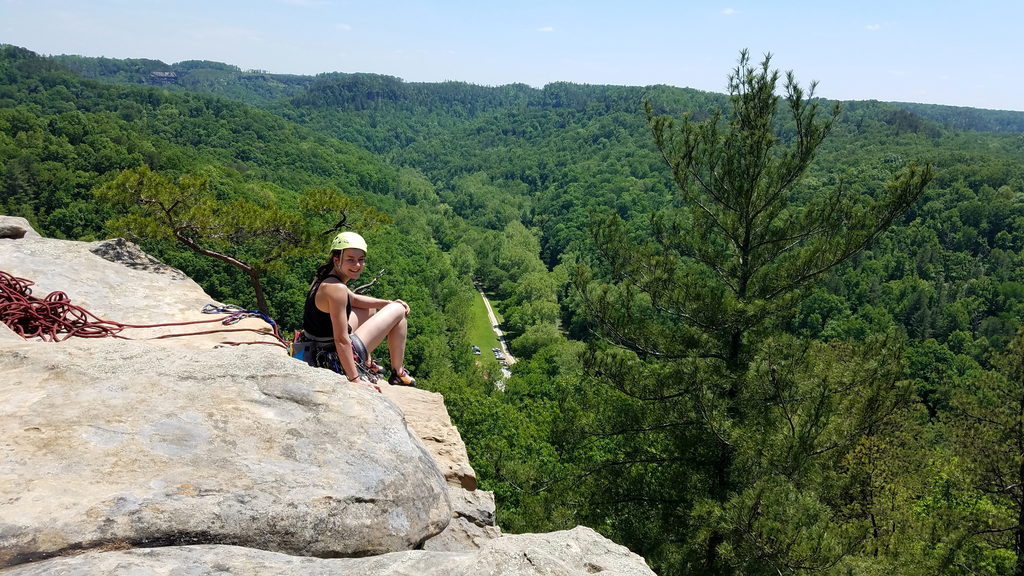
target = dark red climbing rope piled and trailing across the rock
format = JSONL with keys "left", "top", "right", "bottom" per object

{"left": 0, "top": 271, "right": 288, "bottom": 348}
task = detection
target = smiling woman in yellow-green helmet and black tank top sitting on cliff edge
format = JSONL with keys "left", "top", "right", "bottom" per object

{"left": 302, "top": 232, "right": 416, "bottom": 386}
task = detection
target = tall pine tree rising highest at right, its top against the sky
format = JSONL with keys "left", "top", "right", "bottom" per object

{"left": 577, "top": 51, "right": 932, "bottom": 574}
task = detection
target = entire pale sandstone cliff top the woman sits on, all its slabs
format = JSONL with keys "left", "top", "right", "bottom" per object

{"left": 0, "top": 217, "right": 652, "bottom": 576}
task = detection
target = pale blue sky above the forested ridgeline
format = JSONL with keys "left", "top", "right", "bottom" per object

{"left": 6, "top": 0, "right": 1024, "bottom": 111}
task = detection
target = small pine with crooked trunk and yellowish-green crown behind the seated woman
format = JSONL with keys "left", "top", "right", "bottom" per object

{"left": 96, "top": 166, "right": 385, "bottom": 314}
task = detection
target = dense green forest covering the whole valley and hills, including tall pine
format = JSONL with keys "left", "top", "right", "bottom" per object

{"left": 0, "top": 46, "right": 1024, "bottom": 575}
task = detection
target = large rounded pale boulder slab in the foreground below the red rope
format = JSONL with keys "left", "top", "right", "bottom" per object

{"left": 0, "top": 338, "right": 453, "bottom": 566}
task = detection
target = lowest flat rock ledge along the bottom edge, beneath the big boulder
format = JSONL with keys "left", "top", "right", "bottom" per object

{"left": 4, "top": 527, "right": 654, "bottom": 576}
